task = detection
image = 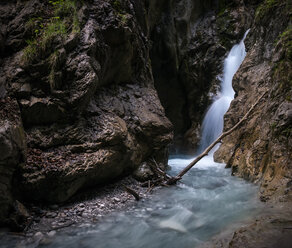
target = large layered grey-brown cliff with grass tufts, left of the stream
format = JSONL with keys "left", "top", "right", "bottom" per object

{"left": 0, "top": 0, "right": 172, "bottom": 226}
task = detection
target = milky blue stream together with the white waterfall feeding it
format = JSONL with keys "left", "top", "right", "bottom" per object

{"left": 0, "top": 31, "right": 259, "bottom": 248}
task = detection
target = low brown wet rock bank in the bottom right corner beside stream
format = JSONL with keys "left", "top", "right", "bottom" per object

{"left": 201, "top": 203, "right": 292, "bottom": 248}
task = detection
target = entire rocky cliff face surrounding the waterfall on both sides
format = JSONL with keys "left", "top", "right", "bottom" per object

{"left": 0, "top": 0, "right": 292, "bottom": 236}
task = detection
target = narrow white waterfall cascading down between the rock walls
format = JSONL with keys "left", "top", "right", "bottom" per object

{"left": 199, "top": 30, "right": 249, "bottom": 152}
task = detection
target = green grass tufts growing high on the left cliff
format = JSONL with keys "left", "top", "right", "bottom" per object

{"left": 22, "top": 0, "right": 80, "bottom": 63}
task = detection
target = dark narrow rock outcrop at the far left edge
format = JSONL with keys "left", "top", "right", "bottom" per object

{"left": 0, "top": 98, "right": 26, "bottom": 225}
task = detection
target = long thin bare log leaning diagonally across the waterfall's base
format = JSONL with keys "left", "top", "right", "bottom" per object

{"left": 166, "top": 92, "right": 266, "bottom": 185}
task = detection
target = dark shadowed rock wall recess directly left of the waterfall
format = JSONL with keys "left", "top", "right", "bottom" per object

{"left": 150, "top": 0, "right": 252, "bottom": 154}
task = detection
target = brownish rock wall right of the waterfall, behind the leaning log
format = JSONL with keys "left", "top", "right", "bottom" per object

{"left": 215, "top": 1, "right": 292, "bottom": 201}
